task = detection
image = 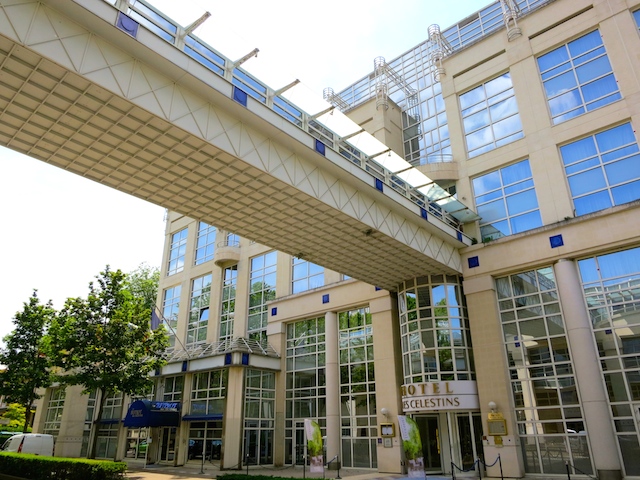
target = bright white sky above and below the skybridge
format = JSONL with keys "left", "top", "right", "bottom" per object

{"left": 0, "top": 0, "right": 492, "bottom": 337}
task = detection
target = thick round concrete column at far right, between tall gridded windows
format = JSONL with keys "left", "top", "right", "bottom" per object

{"left": 554, "top": 259, "right": 622, "bottom": 480}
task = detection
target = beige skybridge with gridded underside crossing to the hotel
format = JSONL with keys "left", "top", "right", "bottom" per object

{"left": 0, "top": 0, "right": 477, "bottom": 290}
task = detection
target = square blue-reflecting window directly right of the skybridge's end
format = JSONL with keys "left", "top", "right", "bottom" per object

{"left": 473, "top": 160, "right": 542, "bottom": 241}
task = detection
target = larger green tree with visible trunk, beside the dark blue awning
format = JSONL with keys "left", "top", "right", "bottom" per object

{"left": 50, "top": 266, "right": 168, "bottom": 458}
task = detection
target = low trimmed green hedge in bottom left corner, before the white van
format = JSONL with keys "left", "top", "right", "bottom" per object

{"left": 0, "top": 452, "right": 127, "bottom": 480}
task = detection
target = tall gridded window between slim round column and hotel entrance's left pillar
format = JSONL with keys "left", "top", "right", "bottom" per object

{"left": 338, "top": 307, "right": 378, "bottom": 468}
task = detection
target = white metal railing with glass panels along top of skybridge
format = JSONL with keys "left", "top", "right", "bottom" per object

{"left": 104, "top": 0, "right": 472, "bottom": 238}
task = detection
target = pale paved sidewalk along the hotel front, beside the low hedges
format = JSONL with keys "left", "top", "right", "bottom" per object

{"left": 126, "top": 460, "right": 396, "bottom": 480}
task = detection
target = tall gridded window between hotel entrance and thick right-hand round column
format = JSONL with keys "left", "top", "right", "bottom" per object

{"left": 496, "top": 267, "right": 592, "bottom": 474}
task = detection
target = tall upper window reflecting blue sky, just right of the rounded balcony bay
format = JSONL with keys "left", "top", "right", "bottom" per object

{"left": 247, "top": 252, "right": 278, "bottom": 342}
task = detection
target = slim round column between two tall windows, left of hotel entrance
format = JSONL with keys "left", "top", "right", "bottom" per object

{"left": 324, "top": 312, "right": 342, "bottom": 462}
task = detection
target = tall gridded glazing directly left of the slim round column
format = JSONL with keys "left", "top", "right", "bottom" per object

{"left": 285, "top": 317, "right": 327, "bottom": 465}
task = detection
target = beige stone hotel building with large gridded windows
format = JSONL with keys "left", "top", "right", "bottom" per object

{"left": 36, "top": 0, "right": 640, "bottom": 479}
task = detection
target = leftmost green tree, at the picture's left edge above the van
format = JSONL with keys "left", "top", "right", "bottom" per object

{"left": 0, "top": 290, "right": 56, "bottom": 432}
